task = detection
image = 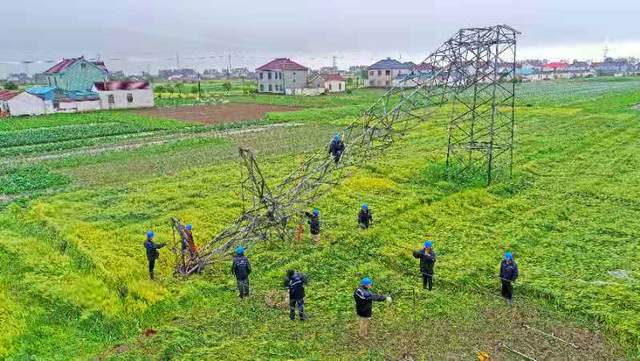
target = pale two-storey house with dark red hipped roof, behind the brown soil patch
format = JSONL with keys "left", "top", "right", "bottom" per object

{"left": 256, "top": 58, "right": 309, "bottom": 94}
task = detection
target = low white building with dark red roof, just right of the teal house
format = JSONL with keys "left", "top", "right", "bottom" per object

{"left": 93, "top": 81, "right": 154, "bottom": 109}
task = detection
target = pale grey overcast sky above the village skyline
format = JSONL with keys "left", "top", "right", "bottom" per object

{"left": 0, "top": 0, "right": 640, "bottom": 75}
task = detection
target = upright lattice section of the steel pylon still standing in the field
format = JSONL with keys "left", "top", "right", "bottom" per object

{"left": 447, "top": 25, "right": 519, "bottom": 184}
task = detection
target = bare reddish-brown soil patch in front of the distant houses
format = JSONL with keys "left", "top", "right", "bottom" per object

{"left": 135, "top": 103, "right": 300, "bottom": 124}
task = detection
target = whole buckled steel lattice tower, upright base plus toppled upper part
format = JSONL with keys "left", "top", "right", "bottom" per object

{"left": 177, "top": 25, "right": 518, "bottom": 275}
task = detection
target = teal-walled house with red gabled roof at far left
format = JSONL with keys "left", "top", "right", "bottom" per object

{"left": 43, "top": 57, "right": 109, "bottom": 91}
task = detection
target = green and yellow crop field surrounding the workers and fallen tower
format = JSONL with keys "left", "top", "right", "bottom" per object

{"left": 0, "top": 78, "right": 640, "bottom": 360}
